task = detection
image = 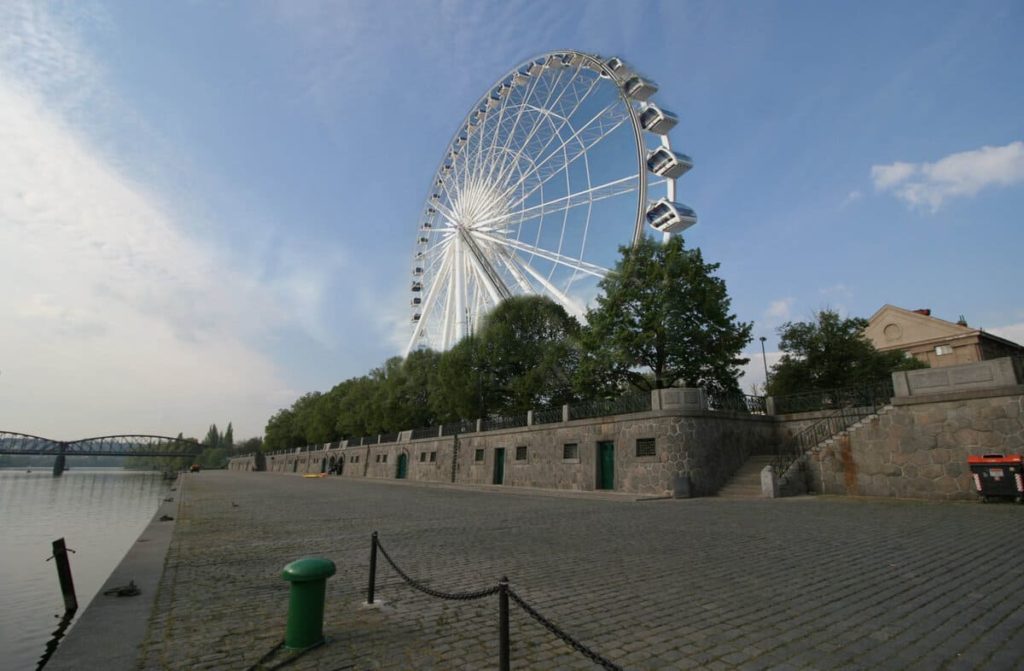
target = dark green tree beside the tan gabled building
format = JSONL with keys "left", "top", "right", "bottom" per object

{"left": 767, "top": 309, "right": 927, "bottom": 395}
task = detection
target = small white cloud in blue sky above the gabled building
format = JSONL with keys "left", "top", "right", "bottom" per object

{"left": 871, "top": 140, "right": 1024, "bottom": 212}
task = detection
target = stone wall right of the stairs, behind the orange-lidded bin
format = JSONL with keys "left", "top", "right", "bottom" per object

{"left": 807, "top": 386, "right": 1024, "bottom": 499}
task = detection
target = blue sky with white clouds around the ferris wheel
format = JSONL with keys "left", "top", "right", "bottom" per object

{"left": 0, "top": 0, "right": 1024, "bottom": 439}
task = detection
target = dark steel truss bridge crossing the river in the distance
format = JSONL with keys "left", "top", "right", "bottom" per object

{"left": 0, "top": 431, "right": 207, "bottom": 475}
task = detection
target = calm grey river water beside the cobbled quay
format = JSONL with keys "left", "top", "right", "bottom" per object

{"left": 0, "top": 469, "right": 173, "bottom": 669}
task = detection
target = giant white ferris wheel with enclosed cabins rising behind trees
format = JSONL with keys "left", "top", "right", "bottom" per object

{"left": 406, "top": 51, "right": 696, "bottom": 354}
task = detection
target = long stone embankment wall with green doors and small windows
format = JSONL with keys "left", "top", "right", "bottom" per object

{"left": 235, "top": 404, "right": 781, "bottom": 497}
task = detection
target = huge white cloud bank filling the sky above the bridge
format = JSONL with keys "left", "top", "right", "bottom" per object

{"left": 0, "top": 79, "right": 295, "bottom": 438}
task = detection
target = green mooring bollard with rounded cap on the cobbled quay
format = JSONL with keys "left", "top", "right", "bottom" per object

{"left": 281, "top": 557, "right": 336, "bottom": 651}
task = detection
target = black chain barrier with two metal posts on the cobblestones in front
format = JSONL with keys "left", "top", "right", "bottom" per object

{"left": 367, "top": 532, "right": 623, "bottom": 671}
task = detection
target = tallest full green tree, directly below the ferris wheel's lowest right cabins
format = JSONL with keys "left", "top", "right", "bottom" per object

{"left": 578, "top": 236, "right": 752, "bottom": 395}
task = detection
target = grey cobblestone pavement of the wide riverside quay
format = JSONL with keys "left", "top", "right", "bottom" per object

{"left": 139, "top": 472, "right": 1024, "bottom": 670}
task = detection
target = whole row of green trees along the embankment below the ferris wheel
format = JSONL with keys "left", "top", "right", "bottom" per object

{"left": 264, "top": 237, "right": 751, "bottom": 451}
